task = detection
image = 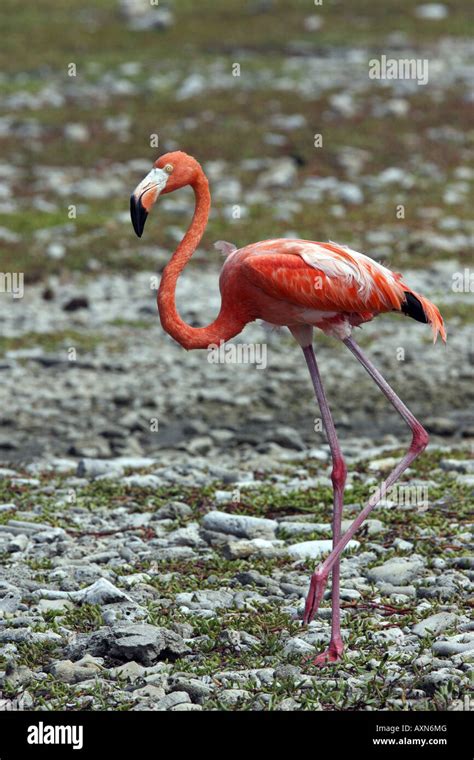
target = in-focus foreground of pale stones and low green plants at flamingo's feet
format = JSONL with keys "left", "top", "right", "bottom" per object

{"left": 0, "top": 444, "right": 474, "bottom": 710}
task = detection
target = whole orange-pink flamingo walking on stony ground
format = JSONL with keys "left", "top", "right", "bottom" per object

{"left": 130, "top": 151, "right": 446, "bottom": 665}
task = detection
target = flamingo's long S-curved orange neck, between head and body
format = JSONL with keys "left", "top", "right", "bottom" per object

{"left": 158, "top": 171, "right": 245, "bottom": 349}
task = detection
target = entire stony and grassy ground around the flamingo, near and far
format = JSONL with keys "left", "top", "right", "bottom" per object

{"left": 0, "top": 0, "right": 474, "bottom": 710}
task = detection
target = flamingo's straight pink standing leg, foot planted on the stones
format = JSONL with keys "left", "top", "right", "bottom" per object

{"left": 303, "top": 345, "right": 347, "bottom": 665}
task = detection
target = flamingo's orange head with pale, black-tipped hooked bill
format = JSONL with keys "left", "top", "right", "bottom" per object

{"left": 130, "top": 150, "right": 202, "bottom": 237}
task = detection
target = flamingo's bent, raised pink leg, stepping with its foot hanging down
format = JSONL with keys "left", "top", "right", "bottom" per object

{"left": 305, "top": 338, "right": 428, "bottom": 620}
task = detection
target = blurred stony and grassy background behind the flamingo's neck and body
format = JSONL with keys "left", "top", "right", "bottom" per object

{"left": 0, "top": 0, "right": 474, "bottom": 462}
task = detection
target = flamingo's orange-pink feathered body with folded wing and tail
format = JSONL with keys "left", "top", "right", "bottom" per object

{"left": 220, "top": 238, "right": 446, "bottom": 339}
